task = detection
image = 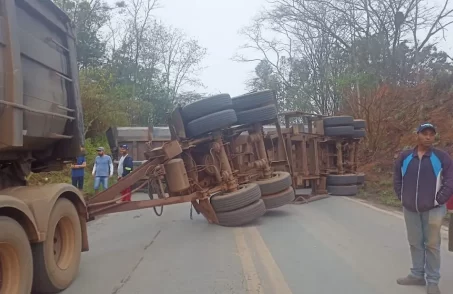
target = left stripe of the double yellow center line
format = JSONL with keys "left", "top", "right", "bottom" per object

{"left": 233, "top": 228, "right": 264, "bottom": 294}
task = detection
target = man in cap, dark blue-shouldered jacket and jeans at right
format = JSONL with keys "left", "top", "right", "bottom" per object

{"left": 393, "top": 123, "right": 453, "bottom": 294}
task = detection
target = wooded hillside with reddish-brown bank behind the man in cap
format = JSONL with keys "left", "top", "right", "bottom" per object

{"left": 235, "top": 0, "right": 453, "bottom": 205}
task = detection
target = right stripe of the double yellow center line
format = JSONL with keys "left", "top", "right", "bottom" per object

{"left": 245, "top": 227, "right": 293, "bottom": 294}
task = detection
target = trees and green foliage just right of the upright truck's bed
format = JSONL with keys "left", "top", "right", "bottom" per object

{"left": 50, "top": 0, "right": 206, "bottom": 132}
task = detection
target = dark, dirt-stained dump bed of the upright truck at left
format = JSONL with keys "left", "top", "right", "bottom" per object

{"left": 0, "top": 0, "right": 83, "bottom": 171}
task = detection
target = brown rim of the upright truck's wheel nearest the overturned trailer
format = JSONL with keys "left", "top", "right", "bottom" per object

{"left": 53, "top": 217, "right": 75, "bottom": 270}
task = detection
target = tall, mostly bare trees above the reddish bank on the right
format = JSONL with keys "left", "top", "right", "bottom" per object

{"left": 237, "top": 0, "right": 453, "bottom": 114}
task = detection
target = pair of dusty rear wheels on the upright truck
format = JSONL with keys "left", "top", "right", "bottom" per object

{"left": 0, "top": 198, "right": 82, "bottom": 294}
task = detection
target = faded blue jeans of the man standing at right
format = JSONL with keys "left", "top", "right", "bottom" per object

{"left": 404, "top": 205, "right": 447, "bottom": 284}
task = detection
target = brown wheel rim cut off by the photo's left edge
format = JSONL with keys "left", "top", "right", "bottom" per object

{"left": 0, "top": 243, "right": 21, "bottom": 294}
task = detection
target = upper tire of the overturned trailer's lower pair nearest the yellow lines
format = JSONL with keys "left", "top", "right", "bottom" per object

{"left": 211, "top": 183, "right": 261, "bottom": 212}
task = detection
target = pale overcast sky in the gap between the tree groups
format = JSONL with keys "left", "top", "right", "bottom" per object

{"left": 154, "top": 0, "right": 266, "bottom": 97}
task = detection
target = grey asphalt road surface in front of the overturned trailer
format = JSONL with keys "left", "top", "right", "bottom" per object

{"left": 64, "top": 195, "right": 453, "bottom": 294}
